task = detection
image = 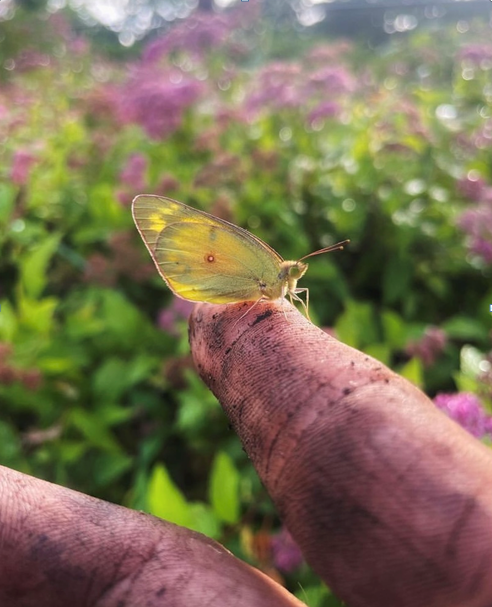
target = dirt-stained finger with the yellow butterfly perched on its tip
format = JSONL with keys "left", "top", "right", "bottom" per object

{"left": 190, "top": 303, "right": 492, "bottom": 607}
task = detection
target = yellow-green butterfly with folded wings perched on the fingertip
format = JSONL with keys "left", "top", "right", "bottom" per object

{"left": 132, "top": 194, "right": 349, "bottom": 317}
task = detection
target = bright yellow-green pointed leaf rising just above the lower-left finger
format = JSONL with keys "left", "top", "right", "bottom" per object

{"left": 147, "top": 464, "right": 193, "bottom": 528}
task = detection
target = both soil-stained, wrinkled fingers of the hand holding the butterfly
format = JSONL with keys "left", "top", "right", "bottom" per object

{"left": 0, "top": 302, "right": 492, "bottom": 607}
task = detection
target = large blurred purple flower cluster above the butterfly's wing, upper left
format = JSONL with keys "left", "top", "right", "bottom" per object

{"left": 120, "top": 66, "right": 203, "bottom": 139}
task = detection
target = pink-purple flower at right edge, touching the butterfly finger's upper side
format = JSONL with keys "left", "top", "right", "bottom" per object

{"left": 434, "top": 392, "right": 492, "bottom": 438}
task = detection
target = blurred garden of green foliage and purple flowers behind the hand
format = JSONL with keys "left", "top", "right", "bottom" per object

{"left": 0, "top": 0, "right": 492, "bottom": 607}
